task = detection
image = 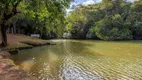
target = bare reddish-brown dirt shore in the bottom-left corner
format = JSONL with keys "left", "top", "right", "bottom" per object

{"left": 0, "top": 51, "right": 33, "bottom": 80}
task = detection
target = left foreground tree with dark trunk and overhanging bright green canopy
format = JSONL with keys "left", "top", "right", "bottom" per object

{"left": 0, "top": 0, "right": 70, "bottom": 46}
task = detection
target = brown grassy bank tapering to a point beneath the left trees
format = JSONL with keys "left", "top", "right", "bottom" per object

{"left": 0, "top": 34, "right": 50, "bottom": 51}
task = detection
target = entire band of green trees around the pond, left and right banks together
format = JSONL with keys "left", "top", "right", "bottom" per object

{"left": 0, "top": 0, "right": 142, "bottom": 46}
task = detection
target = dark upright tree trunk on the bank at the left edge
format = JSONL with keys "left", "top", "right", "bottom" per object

{"left": 1, "top": 23, "right": 7, "bottom": 47}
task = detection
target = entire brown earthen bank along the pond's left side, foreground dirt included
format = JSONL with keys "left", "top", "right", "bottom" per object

{"left": 0, "top": 34, "right": 53, "bottom": 80}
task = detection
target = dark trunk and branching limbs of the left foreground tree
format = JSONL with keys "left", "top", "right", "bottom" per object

{"left": 0, "top": 0, "right": 22, "bottom": 46}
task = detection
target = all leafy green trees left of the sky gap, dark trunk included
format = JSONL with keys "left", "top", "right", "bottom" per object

{"left": 0, "top": 0, "right": 70, "bottom": 46}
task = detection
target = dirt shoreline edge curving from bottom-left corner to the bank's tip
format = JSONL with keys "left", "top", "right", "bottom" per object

{"left": 0, "top": 42, "right": 52, "bottom": 80}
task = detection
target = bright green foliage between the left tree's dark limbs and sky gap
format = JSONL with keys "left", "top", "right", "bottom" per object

{"left": 8, "top": 0, "right": 70, "bottom": 35}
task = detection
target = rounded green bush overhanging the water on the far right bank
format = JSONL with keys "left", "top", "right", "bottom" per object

{"left": 94, "top": 14, "right": 132, "bottom": 40}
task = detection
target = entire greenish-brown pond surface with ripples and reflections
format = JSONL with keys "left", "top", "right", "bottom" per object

{"left": 13, "top": 40, "right": 142, "bottom": 80}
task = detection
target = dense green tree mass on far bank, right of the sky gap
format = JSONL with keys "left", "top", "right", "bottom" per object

{"left": 66, "top": 0, "right": 142, "bottom": 40}
